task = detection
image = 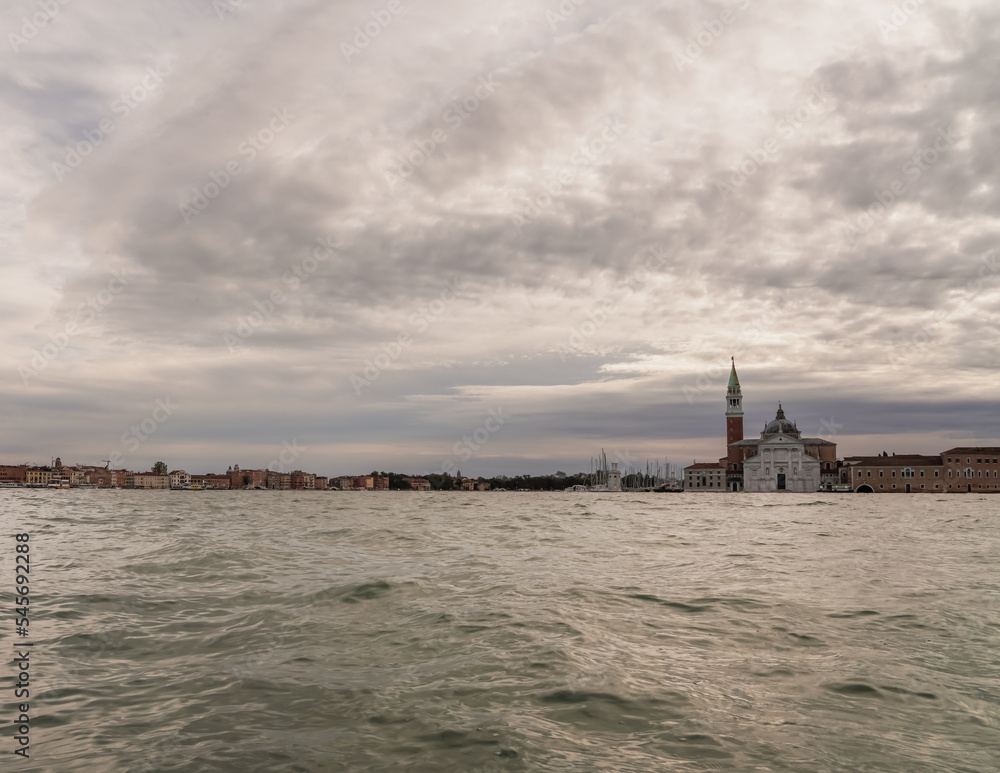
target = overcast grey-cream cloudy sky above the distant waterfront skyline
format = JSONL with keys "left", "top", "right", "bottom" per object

{"left": 0, "top": 0, "right": 1000, "bottom": 475}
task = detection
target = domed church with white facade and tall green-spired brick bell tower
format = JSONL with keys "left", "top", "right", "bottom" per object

{"left": 719, "top": 360, "right": 838, "bottom": 493}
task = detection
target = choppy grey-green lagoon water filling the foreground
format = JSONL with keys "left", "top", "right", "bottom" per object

{"left": 0, "top": 490, "right": 1000, "bottom": 773}
